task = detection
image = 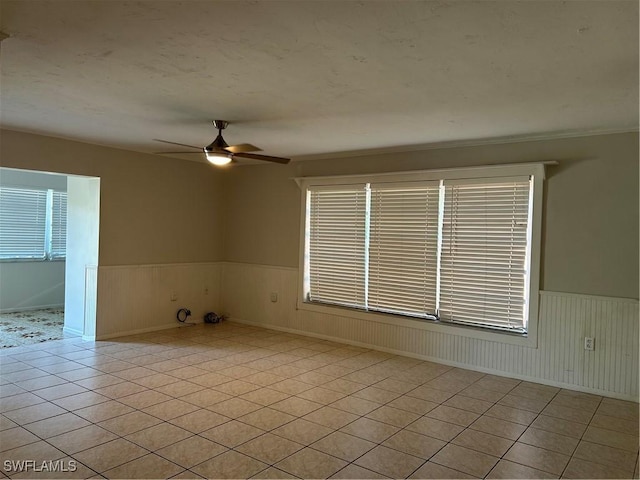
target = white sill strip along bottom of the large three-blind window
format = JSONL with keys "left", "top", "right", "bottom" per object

{"left": 297, "top": 300, "right": 537, "bottom": 348}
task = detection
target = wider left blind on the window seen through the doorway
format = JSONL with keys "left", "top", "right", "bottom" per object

{"left": 0, "top": 187, "right": 47, "bottom": 259}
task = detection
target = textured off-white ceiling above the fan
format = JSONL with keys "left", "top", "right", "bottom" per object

{"left": 0, "top": 0, "right": 638, "bottom": 163}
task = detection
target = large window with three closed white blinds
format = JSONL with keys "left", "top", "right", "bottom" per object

{"left": 299, "top": 165, "right": 544, "bottom": 334}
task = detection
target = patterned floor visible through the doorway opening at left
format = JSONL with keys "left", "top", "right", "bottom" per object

{"left": 0, "top": 308, "right": 64, "bottom": 348}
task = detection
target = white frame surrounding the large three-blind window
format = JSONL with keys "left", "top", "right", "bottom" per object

{"left": 294, "top": 162, "right": 555, "bottom": 348}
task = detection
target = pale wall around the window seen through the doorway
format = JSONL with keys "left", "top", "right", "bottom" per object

{"left": 0, "top": 168, "right": 67, "bottom": 312}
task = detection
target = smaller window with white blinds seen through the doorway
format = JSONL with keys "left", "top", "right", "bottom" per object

{"left": 0, "top": 186, "right": 67, "bottom": 260}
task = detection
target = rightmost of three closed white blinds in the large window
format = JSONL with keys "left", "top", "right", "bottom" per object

{"left": 439, "top": 177, "right": 531, "bottom": 330}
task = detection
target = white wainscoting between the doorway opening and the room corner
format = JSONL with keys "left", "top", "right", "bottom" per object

{"left": 96, "top": 263, "right": 220, "bottom": 339}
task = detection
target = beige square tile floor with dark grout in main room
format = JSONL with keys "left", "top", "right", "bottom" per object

{"left": 0, "top": 322, "right": 639, "bottom": 478}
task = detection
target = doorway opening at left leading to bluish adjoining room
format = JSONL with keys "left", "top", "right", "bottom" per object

{"left": 0, "top": 168, "right": 100, "bottom": 348}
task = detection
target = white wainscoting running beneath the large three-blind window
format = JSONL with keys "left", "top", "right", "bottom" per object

{"left": 221, "top": 263, "right": 640, "bottom": 401}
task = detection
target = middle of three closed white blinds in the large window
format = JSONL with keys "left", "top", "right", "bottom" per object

{"left": 368, "top": 182, "right": 439, "bottom": 317}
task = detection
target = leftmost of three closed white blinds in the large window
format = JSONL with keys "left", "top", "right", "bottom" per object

{"left": 307, "top": 185, "right": 368, "bottom": 308}
